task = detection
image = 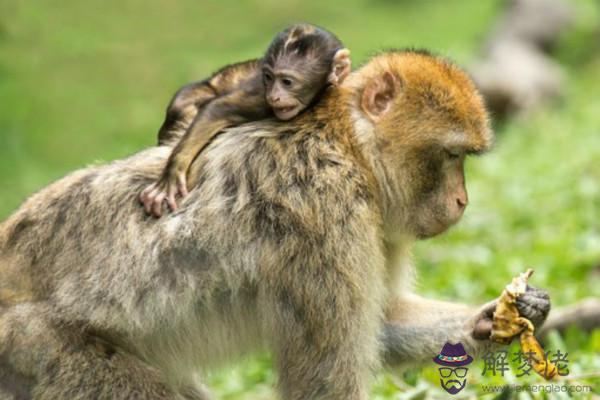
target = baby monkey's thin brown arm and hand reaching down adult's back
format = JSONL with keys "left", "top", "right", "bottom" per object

{"left": 140, "top": 89, "right": 268, "bottom": 217}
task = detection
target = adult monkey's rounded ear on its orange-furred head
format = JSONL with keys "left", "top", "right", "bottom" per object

{"left": 360, "top": 72, "right": 400, "bottom": 122}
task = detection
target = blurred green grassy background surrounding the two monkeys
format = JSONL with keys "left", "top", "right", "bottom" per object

{"left": 0, "top": 0, "right": 600, "bottom": 399}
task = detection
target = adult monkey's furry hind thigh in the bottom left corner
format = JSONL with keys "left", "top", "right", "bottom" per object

{"left": 0, "top": 304, "right": 207, "bottom": 400}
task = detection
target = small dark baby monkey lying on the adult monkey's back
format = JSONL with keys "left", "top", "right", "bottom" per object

{"left": 140, "top": 24, "right": 350, "bottom": 217}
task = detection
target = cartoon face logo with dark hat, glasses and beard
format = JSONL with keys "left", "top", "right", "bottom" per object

{"left": 433, "top": 342, "right": 473, "bottom": 394}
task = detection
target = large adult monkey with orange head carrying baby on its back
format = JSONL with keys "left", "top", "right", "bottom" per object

{"left": 0, "top": 51, "right": 549, "bottom": 400}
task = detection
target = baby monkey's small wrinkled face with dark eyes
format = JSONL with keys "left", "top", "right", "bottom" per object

{"left": 263, "top": 65, "right": 327, "bottom": 121}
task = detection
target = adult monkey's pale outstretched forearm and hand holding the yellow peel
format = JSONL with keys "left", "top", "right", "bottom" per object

{"left": 382, "top": 286, "right": 550, "bottom": 365}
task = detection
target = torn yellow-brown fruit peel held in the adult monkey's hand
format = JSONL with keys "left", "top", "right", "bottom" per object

{"left": 490, "top": 268, "right": 557, "bottom": 380}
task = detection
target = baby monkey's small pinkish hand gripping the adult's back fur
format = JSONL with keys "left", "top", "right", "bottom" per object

{"left": 140, "top": 168, "right": 188, "bottom": 218}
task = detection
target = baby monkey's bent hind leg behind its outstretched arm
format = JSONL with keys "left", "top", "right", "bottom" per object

{"left": 158, "top": 81, "right": 217, "bottom": 145}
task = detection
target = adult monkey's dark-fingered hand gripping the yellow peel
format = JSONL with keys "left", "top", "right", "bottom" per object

{"left": 473, "top": 285, "right": 550, "bottom": 340}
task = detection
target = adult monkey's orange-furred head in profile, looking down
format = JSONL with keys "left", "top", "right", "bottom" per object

{"left": 361, "top": 56, "right": 491, "bottom": 238}
